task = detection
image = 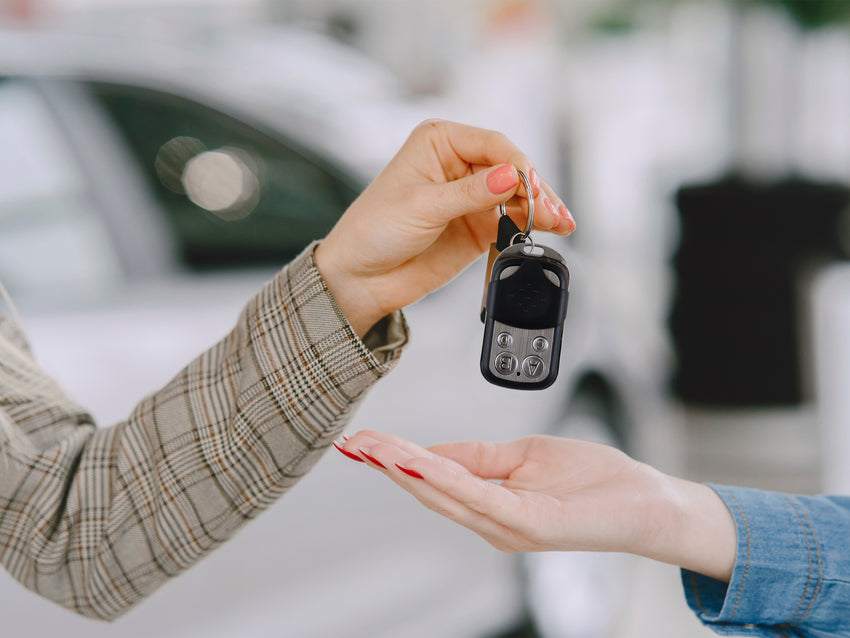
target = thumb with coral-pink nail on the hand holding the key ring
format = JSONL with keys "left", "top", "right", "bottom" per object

{"left": 434, "top": 164, "right": 519, "bottom": 222}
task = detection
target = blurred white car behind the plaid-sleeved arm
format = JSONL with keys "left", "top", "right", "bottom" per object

{"left": 0, "top": 23, "right": 646, "bottom": 638}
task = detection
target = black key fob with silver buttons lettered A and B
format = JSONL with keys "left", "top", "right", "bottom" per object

{"left": 481, "top": 243, "right": 570, "bottom": 390}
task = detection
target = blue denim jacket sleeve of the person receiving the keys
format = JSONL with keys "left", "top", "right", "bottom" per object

{"left": 682, "top": 485, "right": 850, "bottom": 638}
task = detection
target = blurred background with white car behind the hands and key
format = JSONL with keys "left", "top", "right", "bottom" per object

{"left": 0, "top": 0, "right": 850, "bottom": 638}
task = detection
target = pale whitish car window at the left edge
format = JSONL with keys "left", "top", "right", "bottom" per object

{"left": 0, "top": 79, "right": 121, "bottom": 295}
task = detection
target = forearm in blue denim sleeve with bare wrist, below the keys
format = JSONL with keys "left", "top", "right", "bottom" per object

{"left": 620, "top": 466, "right": 850, "bottom": 638}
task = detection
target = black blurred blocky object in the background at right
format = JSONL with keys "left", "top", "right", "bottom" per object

{"left": 670, "top": 176, "right": 850, "bottom": 407}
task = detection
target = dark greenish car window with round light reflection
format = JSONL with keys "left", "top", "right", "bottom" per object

{"left": 89, "top": 83, "right": 359, "bottom": 270}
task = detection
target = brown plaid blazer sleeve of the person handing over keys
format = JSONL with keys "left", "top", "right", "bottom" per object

{"left": 0, "top": 246, "right": 407, "bottom": 619}
